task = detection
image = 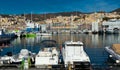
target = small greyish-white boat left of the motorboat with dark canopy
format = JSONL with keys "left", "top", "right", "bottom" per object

{"left": 11, "top": 49, "right": 35, "bottom": 64}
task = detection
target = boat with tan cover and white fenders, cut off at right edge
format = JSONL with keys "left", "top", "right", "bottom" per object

{"left": 105, "top": 44, "right": 120, "bottom": 64}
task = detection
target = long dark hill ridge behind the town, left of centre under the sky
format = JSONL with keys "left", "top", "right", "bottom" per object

{"left": 22, "top": 11, "right": 83, "bottom": 21}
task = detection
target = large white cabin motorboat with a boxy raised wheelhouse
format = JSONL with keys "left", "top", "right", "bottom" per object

{"left": 62, "top": 41, "right": 91, "bottom": 68}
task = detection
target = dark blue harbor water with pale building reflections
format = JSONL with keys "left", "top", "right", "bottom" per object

{"left": 0, "top": 34, "right": 120, "bottom": 70}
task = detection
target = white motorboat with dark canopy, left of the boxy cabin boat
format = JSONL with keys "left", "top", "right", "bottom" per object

{"left": 35, "top": 40, "right": 59, "bottom": 68}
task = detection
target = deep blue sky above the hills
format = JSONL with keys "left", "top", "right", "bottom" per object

{"left": 0, "top": 0, "right": 120, "bottom": 14}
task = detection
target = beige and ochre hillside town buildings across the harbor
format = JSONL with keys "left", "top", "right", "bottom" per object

{"left": 0, "top": 12, "right": 120, "bottom": 33}
